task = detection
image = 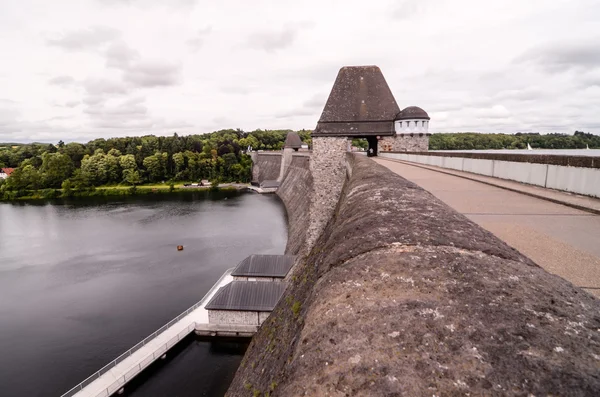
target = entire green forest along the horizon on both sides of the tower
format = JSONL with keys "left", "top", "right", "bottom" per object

{"left": 0, "top": 129, "right": 600, "bottom": 200}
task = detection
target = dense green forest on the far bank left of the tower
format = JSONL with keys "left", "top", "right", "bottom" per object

{"left": 0, "top": 129, "right": 310, "bottom": 198}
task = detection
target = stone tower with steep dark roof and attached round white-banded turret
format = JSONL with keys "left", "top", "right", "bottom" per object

{"left": 308, "top": 66, "right": 429, "bottom": 247}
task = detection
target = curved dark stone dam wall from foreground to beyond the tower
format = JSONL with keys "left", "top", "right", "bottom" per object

{"left": 233, "top": 155, "right": 600, "bottom": 397}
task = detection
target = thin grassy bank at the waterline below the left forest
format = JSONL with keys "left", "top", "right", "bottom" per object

{"left": 0, "top": 182, "right": 247, "bottom": 201}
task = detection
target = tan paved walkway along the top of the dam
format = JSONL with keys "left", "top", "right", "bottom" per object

{"left": 375, "top": 157, "right": 600, "bottom": 297}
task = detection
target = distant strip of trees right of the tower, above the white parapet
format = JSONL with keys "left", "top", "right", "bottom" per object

{"left": 429, "top": 131, "right": 600, "bottom": 150}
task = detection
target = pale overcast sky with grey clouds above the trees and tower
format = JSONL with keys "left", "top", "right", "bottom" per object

{"left": 0, "top": 0, "right": 600, "bottom": 142}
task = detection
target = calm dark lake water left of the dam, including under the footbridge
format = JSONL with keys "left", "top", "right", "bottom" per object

{"left": 0, "top": 192, "right": 287, "bottom": 397}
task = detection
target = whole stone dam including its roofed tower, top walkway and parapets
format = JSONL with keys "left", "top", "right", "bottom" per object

{"left": 57, "top": 66, "right": 600, "bottom": 397}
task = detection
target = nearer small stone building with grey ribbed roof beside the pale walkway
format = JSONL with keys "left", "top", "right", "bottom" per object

{"left": 206, "top": 281, "right": 287, "bottom": 325}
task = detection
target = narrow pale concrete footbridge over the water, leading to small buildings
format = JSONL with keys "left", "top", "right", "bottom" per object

{"left": 62, "top": 268, "right": 233, "bottom": 397}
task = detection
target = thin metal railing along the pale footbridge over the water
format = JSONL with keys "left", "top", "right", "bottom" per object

{"left": 61, "top": 268, "right": 234, "bottom": 397}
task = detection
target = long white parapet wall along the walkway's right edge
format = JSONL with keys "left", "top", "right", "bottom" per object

{"left": 379, "top": 152, "right": 600, "bottom": 197}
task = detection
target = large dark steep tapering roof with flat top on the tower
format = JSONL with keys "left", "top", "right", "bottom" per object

{"left": 313, "top": 66, "right": 400, "bottom": 136}
